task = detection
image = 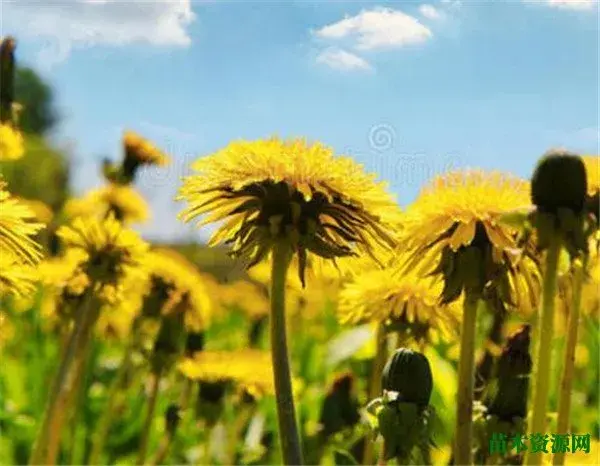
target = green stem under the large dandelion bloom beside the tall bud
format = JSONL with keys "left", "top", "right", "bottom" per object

{"left": 454, "top": 293, "right": 479, "bottom": 466}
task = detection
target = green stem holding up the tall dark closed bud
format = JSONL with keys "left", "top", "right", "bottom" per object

{"left": 524, "top": 234, "right": 561, "bottom": 465}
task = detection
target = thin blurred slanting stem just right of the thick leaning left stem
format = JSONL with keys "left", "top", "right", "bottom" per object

{"left": 88, "top": 317, "right": 141, "bottom": 464}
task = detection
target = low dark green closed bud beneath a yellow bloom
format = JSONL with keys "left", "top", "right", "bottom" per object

{"left": 381, "top": 348, "right": 433, "bottom": 407}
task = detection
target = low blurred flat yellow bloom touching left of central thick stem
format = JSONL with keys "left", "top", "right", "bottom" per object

{"left": 178, "top": 349, "right": 275, "bottom": 396}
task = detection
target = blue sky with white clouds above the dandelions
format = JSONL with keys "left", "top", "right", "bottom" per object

{"left": 1, "top": 0, "right": 599, "bottom": 239}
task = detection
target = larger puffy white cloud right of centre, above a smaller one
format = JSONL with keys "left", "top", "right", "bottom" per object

{"left": 315, "top": 8, "right": 433, "bottom": 50}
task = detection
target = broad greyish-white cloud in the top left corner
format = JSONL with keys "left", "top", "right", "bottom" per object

{"left": 3, "top": 0, "right": 195, "bottom": 64}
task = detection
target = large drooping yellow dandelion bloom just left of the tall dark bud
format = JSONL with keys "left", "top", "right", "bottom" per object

{"left": 402, "top": 170, "right": 541, "bottom": 310}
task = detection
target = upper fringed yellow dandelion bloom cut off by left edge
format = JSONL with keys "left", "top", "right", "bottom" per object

{"left": 0, "top": 181, "right": 44, "bottom": 265}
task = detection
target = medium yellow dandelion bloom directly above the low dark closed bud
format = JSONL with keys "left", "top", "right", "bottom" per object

{"left": 338, "top": 269, "right": 461, "bottom": 342}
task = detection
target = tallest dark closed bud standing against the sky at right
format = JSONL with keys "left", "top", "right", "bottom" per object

{"left": 531, "top": 150, "right": 587, "bottom": 214}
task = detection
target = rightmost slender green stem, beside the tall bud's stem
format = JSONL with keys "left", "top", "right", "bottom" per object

{"left": 553, "top": 255, "right": 588, "bottom": 466}
